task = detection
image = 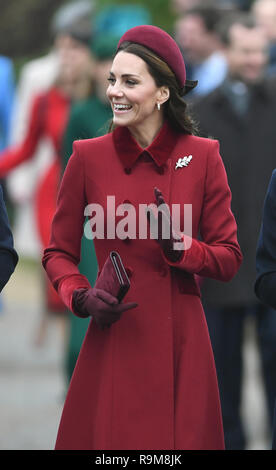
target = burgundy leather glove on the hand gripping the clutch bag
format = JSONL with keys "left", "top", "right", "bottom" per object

{"left": 73, "top": 287, "right": 138, "bottom": 329}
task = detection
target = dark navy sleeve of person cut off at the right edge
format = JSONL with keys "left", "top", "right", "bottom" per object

{"left": 255, "top": 170, "right": 276, "bottom": 309}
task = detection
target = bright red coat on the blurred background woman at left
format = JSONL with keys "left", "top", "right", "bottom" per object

{"left": 0, "top": 86, "right": 70, "bottom": 312}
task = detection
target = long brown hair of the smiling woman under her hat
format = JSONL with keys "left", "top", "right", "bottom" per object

{"left": 110, "top": 41, "right": 198, "bottom": 134}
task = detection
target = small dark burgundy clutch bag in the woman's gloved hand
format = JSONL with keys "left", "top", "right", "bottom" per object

{"left": 95, "top": 251, "right": 130, "bottom": 302}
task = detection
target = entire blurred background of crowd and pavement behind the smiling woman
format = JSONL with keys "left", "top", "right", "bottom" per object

{"left": 0, "top": 0, "right": 276, "bottom": 449}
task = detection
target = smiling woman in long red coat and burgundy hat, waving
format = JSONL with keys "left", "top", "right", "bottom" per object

{"left": 43, "top": 26, "right": 242, "bottom": 450}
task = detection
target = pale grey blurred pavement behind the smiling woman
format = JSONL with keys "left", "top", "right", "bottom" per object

{"left": 0, "top": 261, "right": 269, "bottom": 450}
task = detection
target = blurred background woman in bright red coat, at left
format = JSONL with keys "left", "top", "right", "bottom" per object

{"left": 0, "top": 28, "right": 93, "bottom": 316}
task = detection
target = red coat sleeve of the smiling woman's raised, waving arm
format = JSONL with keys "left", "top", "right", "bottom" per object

{"left": 164, "top": 140, "right": 242, "bottom": 282}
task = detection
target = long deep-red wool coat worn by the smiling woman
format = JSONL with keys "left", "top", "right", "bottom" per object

{"left": 43, "top": 123, "right": 242, "bottom": 450}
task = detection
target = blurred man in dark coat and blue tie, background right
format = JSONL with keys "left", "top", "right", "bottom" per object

{"left": 193, "top": 14, "right": 276, "bottom": 449}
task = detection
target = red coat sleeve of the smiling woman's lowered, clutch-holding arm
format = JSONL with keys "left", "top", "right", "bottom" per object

{"left": 42, "top": 142, "right": 91, "bottom": 310}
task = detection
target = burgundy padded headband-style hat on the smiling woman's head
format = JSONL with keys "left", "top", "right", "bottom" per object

{"left": 117, "top": 25, "right": 197, "bottom": 93}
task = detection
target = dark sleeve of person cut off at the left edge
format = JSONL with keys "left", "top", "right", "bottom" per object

{"left": 0, "top": 186, "right": 18, "bottom": 292}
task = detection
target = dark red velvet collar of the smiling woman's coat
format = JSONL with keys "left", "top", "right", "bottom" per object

{"left": 113, "top": 121, "right": 178, "bottom": 169}
